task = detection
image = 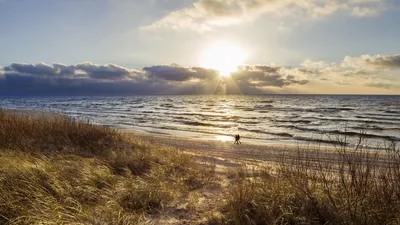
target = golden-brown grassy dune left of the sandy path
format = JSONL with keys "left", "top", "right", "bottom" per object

{"left": 0, "top": 113, "right": 216, "bottom": 224}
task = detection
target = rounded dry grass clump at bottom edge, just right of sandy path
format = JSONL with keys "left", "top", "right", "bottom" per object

{"left": 222, "top": 179, "right": 313, "bottom": 224}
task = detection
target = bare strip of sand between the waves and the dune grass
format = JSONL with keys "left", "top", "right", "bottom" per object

{"left": 122, "top": 130, "right": 352, "bottom": 170}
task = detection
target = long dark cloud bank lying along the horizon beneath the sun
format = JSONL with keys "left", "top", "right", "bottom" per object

{"left": 0, "top": 55, "right": 400, "bottom": 96}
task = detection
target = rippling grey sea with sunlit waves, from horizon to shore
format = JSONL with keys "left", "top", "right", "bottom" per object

{"left": 0, "top": 95, "right": 400, "bottom": 147}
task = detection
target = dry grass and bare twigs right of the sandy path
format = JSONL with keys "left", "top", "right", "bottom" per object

{"left": 217, "top": 142, "right": 400, "bottom": 224}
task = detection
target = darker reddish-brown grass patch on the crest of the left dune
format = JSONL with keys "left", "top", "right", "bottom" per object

{"left": 0, "top": 111, "right": 122, "bottom": 156}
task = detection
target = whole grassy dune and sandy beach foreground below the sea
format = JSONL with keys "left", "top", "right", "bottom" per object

{"left": 0, "top": 110, "right": 400, "bottom": 225}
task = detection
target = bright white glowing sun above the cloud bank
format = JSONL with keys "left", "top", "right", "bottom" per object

{"left": 201, "top": 42, "right": 245, "bottom": 76}
